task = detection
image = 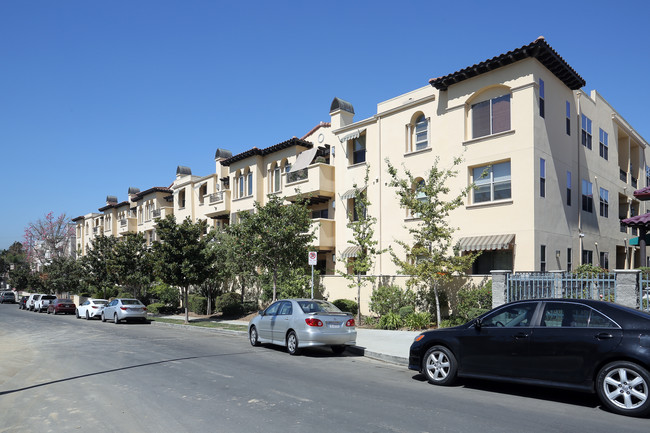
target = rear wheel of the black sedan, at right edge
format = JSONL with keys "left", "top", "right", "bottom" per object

{"left": 596, "top": 361, "right": 650, "bottom": 416}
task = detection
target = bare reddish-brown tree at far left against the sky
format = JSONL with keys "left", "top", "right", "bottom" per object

{"left": 23, "top": 212, "right": 74, "bottom": 267}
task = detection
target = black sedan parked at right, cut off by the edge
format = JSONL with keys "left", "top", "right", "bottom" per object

{"left": 409, "top": 299, "right": 650, "bottom": 416}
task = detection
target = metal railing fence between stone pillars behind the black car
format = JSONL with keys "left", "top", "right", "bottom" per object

{"left": 506, "top": 272, "right": 616, "bottom": 302}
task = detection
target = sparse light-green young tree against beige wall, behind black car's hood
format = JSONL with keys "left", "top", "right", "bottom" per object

{"left": 386, "top": 158, "right": 477, "bottom": 324}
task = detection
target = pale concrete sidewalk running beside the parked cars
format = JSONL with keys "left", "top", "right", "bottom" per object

{"left": 153, "top": 316, "right": 420, "bottom": 367}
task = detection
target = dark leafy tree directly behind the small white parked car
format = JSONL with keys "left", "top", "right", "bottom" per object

{"left": 79, "top": 235, "right": 118, "bottom": 298}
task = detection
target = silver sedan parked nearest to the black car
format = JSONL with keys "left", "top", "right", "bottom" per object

{"left": 248, "top": 299, "right": 357, "bottom": 355}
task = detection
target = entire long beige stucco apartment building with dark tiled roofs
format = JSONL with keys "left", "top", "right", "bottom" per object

{"left": 75, "top": 38, "right": 650, "bottom": 310}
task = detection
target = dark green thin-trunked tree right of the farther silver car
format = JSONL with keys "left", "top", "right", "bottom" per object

{"left": 154, "top": 215, "right": 210, "bottom": 323}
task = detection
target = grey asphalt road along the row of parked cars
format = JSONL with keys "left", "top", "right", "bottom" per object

{"left": 0, "top": 304, "right": 650, "bottom": 433}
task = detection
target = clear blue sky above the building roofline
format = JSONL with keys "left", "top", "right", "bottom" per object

{"left": 0, "top": 0, "right": 650, "bottom": 249}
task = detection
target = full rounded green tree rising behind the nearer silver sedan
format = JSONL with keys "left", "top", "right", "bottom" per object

{"left": 239, "top": 195, "right": 314, "bottom": 300}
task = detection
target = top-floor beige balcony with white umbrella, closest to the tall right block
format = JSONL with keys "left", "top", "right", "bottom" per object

{"left": 283, "top": 163, "right": 334, "bottom": 200}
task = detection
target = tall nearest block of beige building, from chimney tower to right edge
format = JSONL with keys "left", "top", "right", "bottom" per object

{"left": 330, "top": 38, "right": 650, "bottom": 275}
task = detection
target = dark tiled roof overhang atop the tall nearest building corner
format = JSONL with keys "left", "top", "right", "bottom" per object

{"left": 429, "top": 36, "right": 586, "bottom": 90}
